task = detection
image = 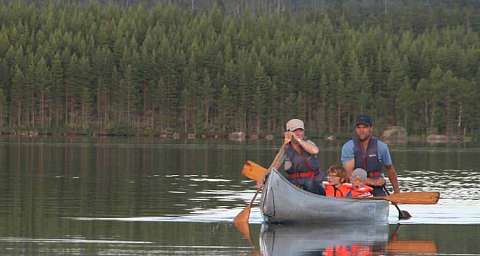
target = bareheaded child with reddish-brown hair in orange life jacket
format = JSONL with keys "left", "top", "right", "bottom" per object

{"left": 323, "top": 166, "right": 352, "bottom": 197}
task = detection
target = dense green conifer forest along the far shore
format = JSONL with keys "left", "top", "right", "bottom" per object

{"left": 0, "top": 1, "right": 480, "bottom": 139}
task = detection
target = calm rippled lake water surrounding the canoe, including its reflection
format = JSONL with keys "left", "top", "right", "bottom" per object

{"left": 0, "top": 137, "right": 480, "bottom": 255}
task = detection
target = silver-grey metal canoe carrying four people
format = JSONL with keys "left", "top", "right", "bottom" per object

{"left": 260, "top": 170, "right": 389, "bottom": 224}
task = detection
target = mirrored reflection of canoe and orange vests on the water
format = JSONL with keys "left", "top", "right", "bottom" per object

{"left": 260, "top": 224, "right": 389, "bottom": 255}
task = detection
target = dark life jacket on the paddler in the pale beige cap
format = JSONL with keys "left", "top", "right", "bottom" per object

{"left": 285, "top": 144, "right": 320, "bottom": 175}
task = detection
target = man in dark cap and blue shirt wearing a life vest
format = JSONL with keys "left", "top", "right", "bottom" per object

{"left": 341, "top": 115, "right": 400, "bottom": 196}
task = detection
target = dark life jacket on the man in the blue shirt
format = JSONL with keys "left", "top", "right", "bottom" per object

{"left": 352, "top": 137, "right": 383, "bottom": 178}
